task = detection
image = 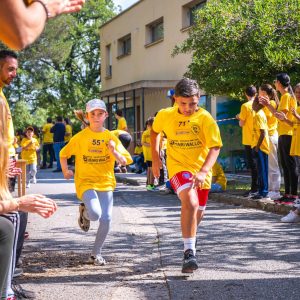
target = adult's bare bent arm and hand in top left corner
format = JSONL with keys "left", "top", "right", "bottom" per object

{"left": 0, "top": 0, "right": 85, "bottom": 50}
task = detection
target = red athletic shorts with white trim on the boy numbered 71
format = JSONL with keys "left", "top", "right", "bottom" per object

{"left": 170, "top": 171, "right": 209, "bottom": 210}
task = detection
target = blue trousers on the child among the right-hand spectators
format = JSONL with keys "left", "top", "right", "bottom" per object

{"left": 253, "top": 150, "right": 269, "bottom": 197}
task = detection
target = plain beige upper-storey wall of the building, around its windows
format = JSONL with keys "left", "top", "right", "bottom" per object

{"left": 100, "top": 0, "right": 198, "bottom": 91}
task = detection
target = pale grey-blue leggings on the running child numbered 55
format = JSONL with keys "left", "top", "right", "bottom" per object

{"left": 82, "top": 190, "right": 113, "bottom": 256}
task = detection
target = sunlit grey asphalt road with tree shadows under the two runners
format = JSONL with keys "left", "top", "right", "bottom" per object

{"left": 19, "top": 170, "right": 300, "bottom": 300}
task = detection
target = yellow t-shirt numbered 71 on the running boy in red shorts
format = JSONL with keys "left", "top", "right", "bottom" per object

{"left": 152, "top": 107, "right": 222, "bottom": 189}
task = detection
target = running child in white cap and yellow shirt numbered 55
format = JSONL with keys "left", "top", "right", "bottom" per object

{"left": 60, "top": 99, "right": 132, "bottom": 265}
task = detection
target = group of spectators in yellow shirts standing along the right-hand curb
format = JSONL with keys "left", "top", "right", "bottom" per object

{"left": 237, "top": 73, "right": 300, "bottom": 222}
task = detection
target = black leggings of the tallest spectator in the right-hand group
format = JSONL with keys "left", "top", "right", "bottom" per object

{"left": 278, "top": 135, "right": 298, "bottom": 196}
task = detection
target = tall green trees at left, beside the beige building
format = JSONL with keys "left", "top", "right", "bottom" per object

{"left": 5, "top": 0, "right": 115, "bottom": 125}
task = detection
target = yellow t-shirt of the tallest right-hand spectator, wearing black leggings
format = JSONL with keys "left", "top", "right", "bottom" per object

{"left": 278, "top": 93, "right": 297, "bottom": 136}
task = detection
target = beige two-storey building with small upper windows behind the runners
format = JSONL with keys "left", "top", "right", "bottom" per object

{"left": 100, "top": 0, "right": 245, "bottom": 171}
